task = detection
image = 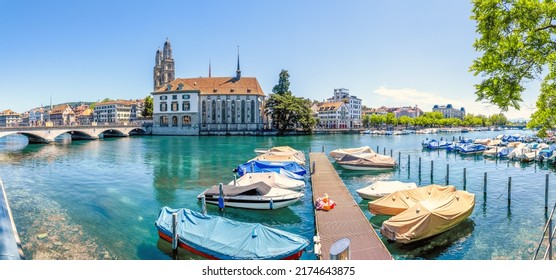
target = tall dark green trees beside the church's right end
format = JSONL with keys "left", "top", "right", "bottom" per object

{"left": 265, "top": 69, "right": 317, "bottom": 134}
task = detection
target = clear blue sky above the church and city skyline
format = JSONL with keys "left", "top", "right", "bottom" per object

{"left": 0, "top": 0, "right": 538, "bottom": 118}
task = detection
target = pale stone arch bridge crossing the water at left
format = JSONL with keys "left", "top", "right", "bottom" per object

{"left": 0, "top": 125, "right": 150, "bottom": 143}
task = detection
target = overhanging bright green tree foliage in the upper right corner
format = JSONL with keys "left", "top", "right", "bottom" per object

{"left": 470, "top": 0, "right": 556, "bottom": 136}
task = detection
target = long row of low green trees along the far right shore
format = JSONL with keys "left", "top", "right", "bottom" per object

{"left": 362, "top": 112, "right": 508, "bottom": 128}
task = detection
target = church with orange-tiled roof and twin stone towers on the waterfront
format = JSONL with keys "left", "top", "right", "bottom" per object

{"left": 151, "top": 39, "right": 266, "bottom": 135}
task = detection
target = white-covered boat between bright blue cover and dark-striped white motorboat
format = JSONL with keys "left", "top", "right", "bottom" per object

{"left": 228, "top": 172, "right": 305, "bottom": 191}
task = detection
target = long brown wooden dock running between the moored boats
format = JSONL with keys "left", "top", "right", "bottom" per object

{"left": 309, "top": 153, "right": 393, "bottom": 260}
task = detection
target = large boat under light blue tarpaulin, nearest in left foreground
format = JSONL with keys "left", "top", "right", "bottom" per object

{"left": 155, "top": 206, "right": 309, "bottom": 260}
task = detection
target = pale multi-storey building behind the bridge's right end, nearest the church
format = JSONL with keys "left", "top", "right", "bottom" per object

{"left": 94, "top": 100, "right": 131, "bottom": 124}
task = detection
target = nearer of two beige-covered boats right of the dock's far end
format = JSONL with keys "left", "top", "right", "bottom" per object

{"left": 336, "top": 153, "right": 396, "bottom": 170}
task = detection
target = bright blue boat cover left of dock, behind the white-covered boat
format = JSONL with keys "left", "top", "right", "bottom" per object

{"left": 237, "top": 161, "right": 307, "bottom": 180}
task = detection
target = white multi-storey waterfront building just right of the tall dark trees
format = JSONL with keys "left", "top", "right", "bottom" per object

{"left": 317, "top": 101, "right": 353, "bottom": 129}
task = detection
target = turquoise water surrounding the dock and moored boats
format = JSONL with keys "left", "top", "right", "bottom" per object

{"left": 0, "top": 131, "right": 556, "bottom": 260}
